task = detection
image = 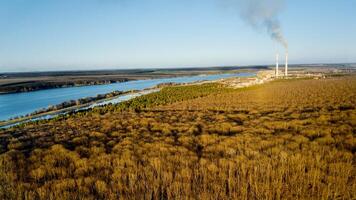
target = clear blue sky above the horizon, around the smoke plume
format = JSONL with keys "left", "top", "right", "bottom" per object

{"left": 0, "top": 0, "right": 356, "bottom": 72}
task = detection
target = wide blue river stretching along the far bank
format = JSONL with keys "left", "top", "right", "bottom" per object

{"left": 0, "top": 73, "right": 255, "bottom": 120}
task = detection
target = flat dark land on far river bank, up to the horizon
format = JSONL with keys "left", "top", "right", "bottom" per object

{"left": 0, "top": 66, "right": 267, "bottom": 94}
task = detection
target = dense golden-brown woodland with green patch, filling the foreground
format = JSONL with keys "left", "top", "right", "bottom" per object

{"left": 0, "top": 76, "right": 356, "bottom": 199}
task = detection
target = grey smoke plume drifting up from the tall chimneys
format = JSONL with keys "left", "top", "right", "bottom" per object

{"left": 229, "top": 0, "right": 288, "bottom": 49}
